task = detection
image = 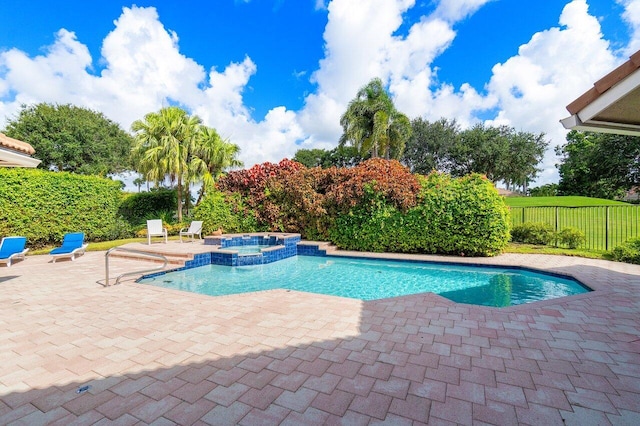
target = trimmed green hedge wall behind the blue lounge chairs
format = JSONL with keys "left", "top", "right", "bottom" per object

{"left": 0, "top": 168, "right": 130, "bottom": 248}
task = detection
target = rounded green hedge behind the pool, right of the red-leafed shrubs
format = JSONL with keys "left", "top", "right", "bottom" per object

{"left": 329, "top": 173, "right": 510, "bottom": 256}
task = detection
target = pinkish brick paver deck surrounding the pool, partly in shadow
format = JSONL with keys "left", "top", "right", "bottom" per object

{"left": 0, "top": 243, "right": 640, "bottom": 425}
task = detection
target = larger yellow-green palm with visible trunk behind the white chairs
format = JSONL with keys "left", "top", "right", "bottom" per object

{"left": 131, "top": 106, "right": 201, "bottom": 222}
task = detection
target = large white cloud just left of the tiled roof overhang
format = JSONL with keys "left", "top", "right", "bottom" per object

{"left": 488, "top": 0, "right": 619, "bottom": 183}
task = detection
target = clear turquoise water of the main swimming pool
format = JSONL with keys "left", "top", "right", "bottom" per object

{"left": 139, "top": 256, "right": 589, "bottom": 307}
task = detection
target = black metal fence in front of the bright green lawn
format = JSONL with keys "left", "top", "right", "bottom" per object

{"left": 511, "top": 205, "right": 640, "bottom": 250}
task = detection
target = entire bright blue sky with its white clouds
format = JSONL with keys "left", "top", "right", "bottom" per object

{"left": 0, "top": 0, "right": 640, "bottom": 183}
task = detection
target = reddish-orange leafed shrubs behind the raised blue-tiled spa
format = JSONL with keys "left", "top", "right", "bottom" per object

{"left": 217, "top": 158, "right": 420, "bottom": 238}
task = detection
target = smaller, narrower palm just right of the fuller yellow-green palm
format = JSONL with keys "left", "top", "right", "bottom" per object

{"left": 190, "top": 126, "right": 244, "bottom": 204}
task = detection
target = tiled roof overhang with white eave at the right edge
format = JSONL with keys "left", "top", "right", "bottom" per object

{"left": 560, "top": 51, "right": 640, "bottom": 136}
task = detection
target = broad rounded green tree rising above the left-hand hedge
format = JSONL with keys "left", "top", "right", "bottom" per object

{"left": 3, "top": 103, "right": 133, "bottom": 176}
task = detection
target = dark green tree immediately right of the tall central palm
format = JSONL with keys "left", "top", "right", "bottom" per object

{"left": 402, "top": 118, "right": 460, "bottom": 174}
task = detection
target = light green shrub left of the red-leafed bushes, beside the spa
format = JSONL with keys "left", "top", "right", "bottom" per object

{"left": 193, "top": 191, "right": 258, "bottom": 236}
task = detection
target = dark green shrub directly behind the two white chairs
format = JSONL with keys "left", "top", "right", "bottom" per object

{"left": 118, "top": 188, "right": 178, "bottom": 225}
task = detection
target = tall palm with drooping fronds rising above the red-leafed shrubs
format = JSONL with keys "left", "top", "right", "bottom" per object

{"left": 340, "top": 78, "right": 411, "bottom": 159}
